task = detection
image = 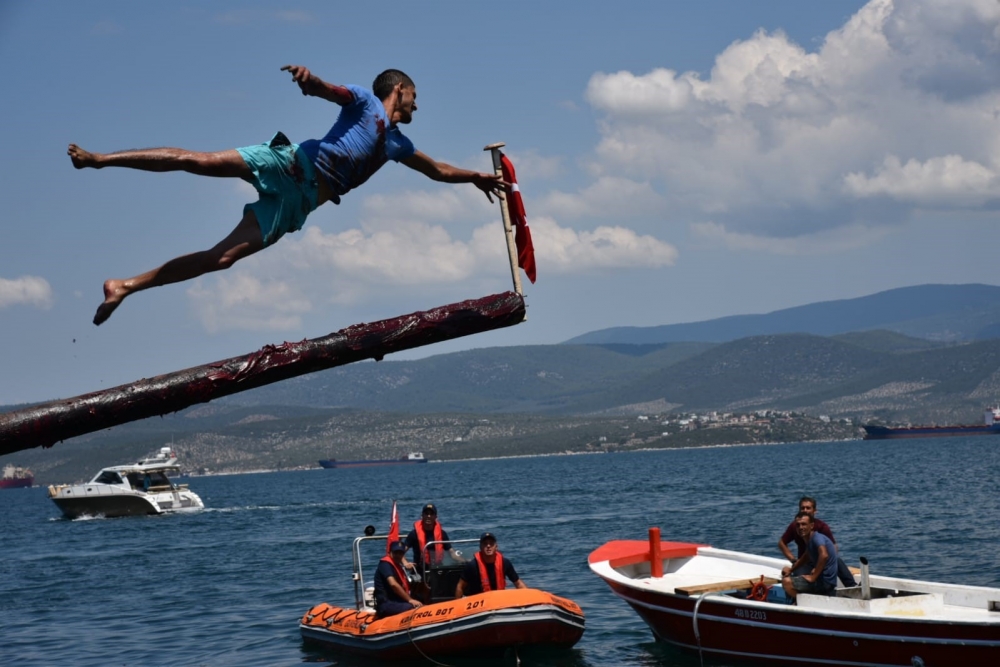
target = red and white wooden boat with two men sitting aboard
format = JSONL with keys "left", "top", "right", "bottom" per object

{"left": 588, "top": 528, "right": 1000, "bottom": 667}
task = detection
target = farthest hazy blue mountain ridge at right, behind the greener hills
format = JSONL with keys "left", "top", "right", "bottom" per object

{"left": 566, "top": 285, "right": 1000, "bottom": 345}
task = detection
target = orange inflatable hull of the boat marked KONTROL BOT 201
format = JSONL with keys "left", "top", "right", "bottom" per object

{"left": 299, "top": 589, "right": 584, "bottom": 660}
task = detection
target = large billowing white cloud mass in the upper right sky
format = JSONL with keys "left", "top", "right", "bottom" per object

{"left": 580, "top": 0, "right": 1000, "bottom": 245}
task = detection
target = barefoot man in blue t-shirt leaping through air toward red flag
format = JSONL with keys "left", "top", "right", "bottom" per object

{"left": 67, "top": 65, "right": 504, "bottom": 324}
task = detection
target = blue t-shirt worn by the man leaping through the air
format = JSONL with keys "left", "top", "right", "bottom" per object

{"left": 299, "top": 85, "right": 416, "bottom": 203}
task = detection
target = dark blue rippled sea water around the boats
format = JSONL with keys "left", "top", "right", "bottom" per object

{"left": 0, "top": 436, "right": 1000, "bottom": 667}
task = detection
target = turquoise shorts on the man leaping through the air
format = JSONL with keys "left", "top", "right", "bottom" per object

{"left": 236, "top": 132, "right": 318, "bottom": 247}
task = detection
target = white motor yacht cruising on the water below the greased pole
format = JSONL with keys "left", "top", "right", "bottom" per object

{"left": 49, "top": 447, "right": 205, "bottom": 519}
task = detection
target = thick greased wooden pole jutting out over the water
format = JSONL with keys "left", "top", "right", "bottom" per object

{"left": 0, "top": 292, "right": 525, "bottom": 455}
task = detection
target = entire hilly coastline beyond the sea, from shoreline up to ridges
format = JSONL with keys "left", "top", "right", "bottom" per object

{"left": 6, "top": 285, "right": 1000, "bottom": 479}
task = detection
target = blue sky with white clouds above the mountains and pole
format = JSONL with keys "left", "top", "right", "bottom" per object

{"left": 0, "top": 0, "right": 1000, "bottom": 403}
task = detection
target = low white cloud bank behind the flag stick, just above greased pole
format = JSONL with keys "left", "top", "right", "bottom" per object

{"left": 187, "top": 209, "right": 677, "bottom": 331}
